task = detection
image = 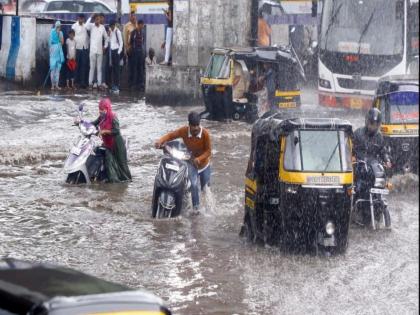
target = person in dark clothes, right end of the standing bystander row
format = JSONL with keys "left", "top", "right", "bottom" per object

{"left": 130, "top": 20, "right": 145, "bottom": 91}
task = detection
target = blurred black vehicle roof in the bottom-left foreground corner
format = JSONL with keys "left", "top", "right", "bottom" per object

{"left": 0, "top": 259, "right": 171, "bottom": 315}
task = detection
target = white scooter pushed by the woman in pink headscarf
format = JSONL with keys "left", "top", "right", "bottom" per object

{"left": 64, "top": 105, "right": 107, "bottom": 185}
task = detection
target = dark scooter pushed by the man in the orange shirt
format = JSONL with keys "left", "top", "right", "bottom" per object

{"left": 152, "top": 141, "right": 191, "bottom": 219}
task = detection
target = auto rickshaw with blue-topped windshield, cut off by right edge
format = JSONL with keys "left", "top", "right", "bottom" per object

{"left": 373, "top": 76, "right": 419, "bottom": 173}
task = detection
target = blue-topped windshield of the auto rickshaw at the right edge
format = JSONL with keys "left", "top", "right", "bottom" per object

{"left": 380, "top": 92, "right": 419, "bottom": 124}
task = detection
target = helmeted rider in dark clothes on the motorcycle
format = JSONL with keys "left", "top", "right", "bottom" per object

{"left": 353, "top": 108, "right": 392, "bottom": 168}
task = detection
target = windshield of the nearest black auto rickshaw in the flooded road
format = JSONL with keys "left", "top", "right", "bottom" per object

{"left": 284, "top": 130, "right": 352, "bottom": 172}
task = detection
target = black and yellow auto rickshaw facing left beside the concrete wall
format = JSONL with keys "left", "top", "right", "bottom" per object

{"left": 201, "top": 47, "right": 304, "bottom": 123}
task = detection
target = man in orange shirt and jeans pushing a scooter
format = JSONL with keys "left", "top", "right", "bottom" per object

{"left": 155, "top": 112, "right": 211, "bottom": 210}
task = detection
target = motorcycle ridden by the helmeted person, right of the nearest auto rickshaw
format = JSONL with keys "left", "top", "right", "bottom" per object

{"left": 353, "top": 159, "right": 391, "bottom": 230}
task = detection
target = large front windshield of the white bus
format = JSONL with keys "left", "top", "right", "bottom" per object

{"left": 320, "top": 0, "right": 404, "bottom": 56}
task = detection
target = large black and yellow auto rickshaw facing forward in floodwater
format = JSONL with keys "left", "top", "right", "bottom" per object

{"left": 241, "top": 113, "right": 353, "bottom": 253}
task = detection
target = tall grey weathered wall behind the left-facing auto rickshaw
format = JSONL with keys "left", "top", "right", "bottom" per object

{"left": 173, "top": 0, "right": 251, "bottom": 67}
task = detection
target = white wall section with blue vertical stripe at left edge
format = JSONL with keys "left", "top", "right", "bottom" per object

{"left": 0, "top": 16, "right": 36, "bottom": 83}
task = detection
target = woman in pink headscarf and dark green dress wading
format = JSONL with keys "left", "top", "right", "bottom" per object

{"left": 92, "top": 98, "right": 131, "bottom": 183}
